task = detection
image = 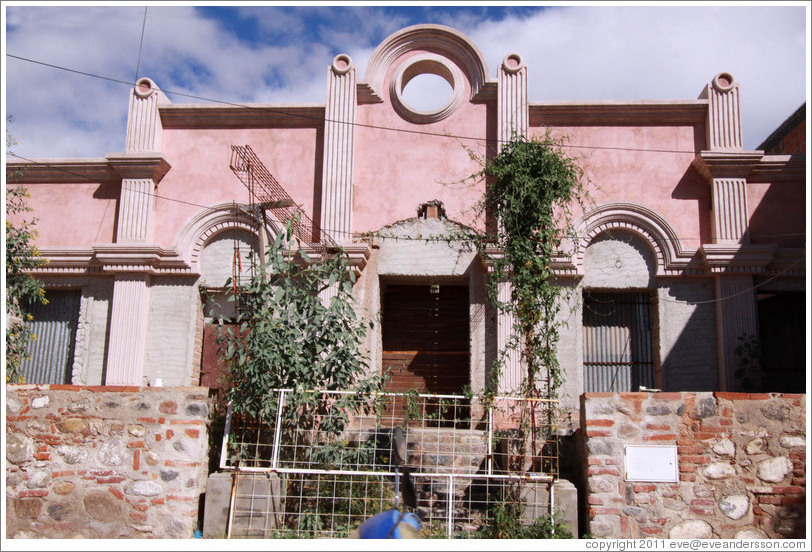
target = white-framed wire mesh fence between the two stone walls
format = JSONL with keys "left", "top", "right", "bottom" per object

{"left": 221, "top": 390, "right": 558, "bottom": 538}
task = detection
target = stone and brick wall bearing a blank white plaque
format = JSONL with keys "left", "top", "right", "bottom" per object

{"left": 581, "top": 392, "right": 806, "bottom": 539}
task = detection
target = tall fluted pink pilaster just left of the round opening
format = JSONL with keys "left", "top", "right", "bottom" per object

{"left": 321, "top": 54, "right": 357, "bottom": 244}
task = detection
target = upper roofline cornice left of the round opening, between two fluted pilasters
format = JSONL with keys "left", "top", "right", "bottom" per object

{"left": 159, "top": 104, "right": 325, "bottom": 129}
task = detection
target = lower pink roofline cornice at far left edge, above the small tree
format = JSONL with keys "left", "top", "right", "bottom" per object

{"left": 6, "top": 159, "right": 120, "bottom": 184}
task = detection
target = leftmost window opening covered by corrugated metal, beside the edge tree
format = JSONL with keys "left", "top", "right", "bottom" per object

{"left": 21, "top": 290, "right": 82, "bottom": 384}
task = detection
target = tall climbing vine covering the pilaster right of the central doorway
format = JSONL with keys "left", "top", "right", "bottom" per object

{"left": 477, "top": 134, "right": 587, "bottom": 398}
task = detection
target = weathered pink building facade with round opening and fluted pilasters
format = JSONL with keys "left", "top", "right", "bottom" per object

{"left": 7, "top": 25, "right": 807, "bottom": 424}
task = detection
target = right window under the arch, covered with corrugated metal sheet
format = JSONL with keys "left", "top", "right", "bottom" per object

{"left": 584, "top": 291, "right": 655, "bottom": 392}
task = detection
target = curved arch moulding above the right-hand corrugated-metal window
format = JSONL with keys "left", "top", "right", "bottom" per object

{"left": 573, "top": 202, "right": 690, "bottom": 276}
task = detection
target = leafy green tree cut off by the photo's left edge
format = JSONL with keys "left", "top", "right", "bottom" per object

{"left": 6, "top": 126, "right": 47, "bottom": 383}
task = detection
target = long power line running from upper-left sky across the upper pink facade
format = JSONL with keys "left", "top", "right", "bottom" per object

{"left": 6, "top": 53, "right": 696, "bottom": 154}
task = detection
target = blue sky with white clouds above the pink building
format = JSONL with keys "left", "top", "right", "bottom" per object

{"left": 3, "top": 1, "right": 809, "bottom": 159}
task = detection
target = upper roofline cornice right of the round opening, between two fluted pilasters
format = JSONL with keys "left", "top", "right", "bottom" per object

{"left": 530, "top": 100, "right": 708, "bottom": 126}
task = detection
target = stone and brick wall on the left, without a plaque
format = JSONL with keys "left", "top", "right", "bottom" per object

{"left": 5, "top": 385, "right": 209, "bottom": 538}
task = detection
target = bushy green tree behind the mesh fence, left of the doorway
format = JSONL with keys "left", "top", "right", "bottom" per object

{"left": 217, "top": 222, "right": 381, "bottom": 461}
